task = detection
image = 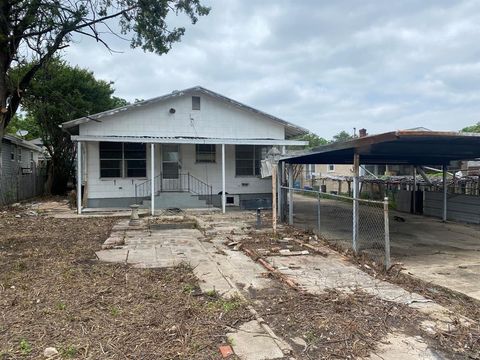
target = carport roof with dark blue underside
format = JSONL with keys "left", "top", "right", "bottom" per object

{"left": 282, "top": 130, "right": 480, "bottom": 165}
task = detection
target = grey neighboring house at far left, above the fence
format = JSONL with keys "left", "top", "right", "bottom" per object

{"left": 0, "top": 134, "right": 43, "bottom": 177}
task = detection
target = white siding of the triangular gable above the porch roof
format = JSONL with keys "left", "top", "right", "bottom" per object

{"left": 80, "top": 93, "right": 285, "bottom": 139}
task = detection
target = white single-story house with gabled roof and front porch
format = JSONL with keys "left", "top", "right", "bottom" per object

{"left": 62, "top": 87, "right": 308, "bottom": 212}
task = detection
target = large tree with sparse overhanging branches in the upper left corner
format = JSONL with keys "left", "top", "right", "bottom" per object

{"left": 0, "top": 0, "right": 210, "bottom": 140}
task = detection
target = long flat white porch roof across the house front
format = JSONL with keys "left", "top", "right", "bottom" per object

{"left": 72, "top": 135, "right": 308, "bottom": 146}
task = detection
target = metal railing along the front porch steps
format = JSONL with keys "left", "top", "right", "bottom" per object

{"left": 135, "top": 173, "right": 213, "bottom": 205}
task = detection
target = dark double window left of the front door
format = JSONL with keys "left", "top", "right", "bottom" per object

{"left": 100, "top": 142, "right": 147, "bottom": 178}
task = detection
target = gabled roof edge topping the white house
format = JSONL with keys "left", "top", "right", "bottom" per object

{"left": 60, "top": 86, "right": 309, "bottom": 138}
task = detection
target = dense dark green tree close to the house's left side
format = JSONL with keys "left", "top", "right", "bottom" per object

{"left": 16, "top": 59, "right": 126, "bottom": 194}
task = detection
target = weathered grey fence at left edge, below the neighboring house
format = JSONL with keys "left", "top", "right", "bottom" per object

{"left": 0, "top": 169, "right": 46, "bottom": 206}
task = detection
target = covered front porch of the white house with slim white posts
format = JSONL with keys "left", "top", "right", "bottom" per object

{"left": 72, "top": 135, "right": 305, "bottom": 214}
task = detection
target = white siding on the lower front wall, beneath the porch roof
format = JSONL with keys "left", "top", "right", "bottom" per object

{"left": 86, "top": 142, "right": 271, "bottom": 199}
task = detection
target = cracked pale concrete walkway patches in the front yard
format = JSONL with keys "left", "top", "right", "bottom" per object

{"left": 97, "top": 212, "right": 464, "bottom": 360}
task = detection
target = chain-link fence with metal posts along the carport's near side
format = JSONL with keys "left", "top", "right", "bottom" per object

{"left": 283, "top": 187, "right": 390, "bottom": 267}
